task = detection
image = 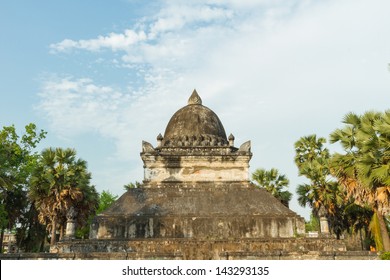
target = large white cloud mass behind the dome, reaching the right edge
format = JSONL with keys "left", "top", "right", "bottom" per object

{"left": 40, "top": 0, "right": 390, "bottom": 219}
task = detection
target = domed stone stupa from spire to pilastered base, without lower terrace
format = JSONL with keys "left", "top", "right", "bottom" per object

{"left": 91, "top": 90, "right": 304, "bottom": 243}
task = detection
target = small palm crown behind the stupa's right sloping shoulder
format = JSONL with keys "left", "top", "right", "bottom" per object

{"left": 252, "top": 168, "right": 292, "bottom": 207}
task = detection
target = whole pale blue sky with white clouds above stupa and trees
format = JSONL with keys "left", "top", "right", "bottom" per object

{"left": 0, "top": 0, "right": 390, "bottom": 218}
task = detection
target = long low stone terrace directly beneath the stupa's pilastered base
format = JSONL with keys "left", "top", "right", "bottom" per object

{"left": 52, "top": 238, "right": 345, "bottom": 260}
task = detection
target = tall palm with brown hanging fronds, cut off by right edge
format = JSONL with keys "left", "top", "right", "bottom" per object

{"left": 330, "top": 111, "right": 390, "bottom": 251}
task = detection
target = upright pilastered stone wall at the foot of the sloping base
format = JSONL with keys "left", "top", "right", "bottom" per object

{"left": 97, "top": 216, "right": 297, "bottom": 239}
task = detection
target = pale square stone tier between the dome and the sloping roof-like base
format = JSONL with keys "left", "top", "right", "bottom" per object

{"left": 141, "top": 147, "right": 252, "bottom": 183}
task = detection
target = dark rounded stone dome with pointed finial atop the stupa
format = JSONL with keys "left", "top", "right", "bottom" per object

{"left": 163, "top": 90, "right": 228, "bottom": 146}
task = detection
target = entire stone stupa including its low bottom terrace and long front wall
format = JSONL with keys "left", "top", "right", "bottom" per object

{"left": 1, "top": 91, "right": 372, "bottom": 260}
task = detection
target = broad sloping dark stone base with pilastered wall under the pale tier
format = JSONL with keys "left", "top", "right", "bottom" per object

{"left": 91, "top": 182, "right": 304, "bottom": 239}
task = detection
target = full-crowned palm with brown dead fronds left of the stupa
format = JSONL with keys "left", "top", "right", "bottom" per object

{"left": 29, "top": 148, "right": 98, "bottom": 245}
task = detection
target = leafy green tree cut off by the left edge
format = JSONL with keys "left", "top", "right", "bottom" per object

{"left": 0, "top": 123, "right": 46, "bottom": 252}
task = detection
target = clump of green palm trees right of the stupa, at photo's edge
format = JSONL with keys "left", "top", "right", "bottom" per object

{"left": 295, "top": 111, "right": 390, "bottom": 251}
